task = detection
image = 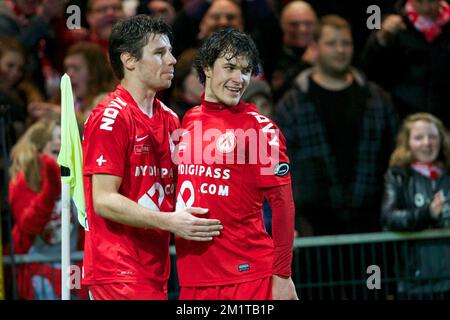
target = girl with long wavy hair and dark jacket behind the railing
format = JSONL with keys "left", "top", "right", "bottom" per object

{"left": 381, "top": 113, "right": 450, "bottom": 299}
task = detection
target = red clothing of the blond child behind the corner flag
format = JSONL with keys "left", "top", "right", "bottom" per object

{"left": 8, "top": 155, "right": 84, "bottom": 299}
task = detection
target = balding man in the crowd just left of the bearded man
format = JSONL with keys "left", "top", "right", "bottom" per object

{"left": 271, "top": 1, "right": 317, "bottom": 101}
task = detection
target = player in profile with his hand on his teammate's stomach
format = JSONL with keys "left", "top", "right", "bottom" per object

{"left": 83, "top": 15, "right": 222, "bottom": 299}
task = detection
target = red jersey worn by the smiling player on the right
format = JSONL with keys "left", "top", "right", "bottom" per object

{"left": 176, "top": 96, "right": 291, "bottom": 286}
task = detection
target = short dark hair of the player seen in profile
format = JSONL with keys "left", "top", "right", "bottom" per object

{"left": 109, "top": 14, "right": 172, "bottom": 79}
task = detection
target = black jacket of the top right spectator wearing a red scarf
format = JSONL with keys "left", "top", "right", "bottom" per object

{"left": 361, "top": 10, "right": 450, "bottom": 127}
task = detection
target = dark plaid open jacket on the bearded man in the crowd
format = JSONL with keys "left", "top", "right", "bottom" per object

{"left": 274, "top": 69, "right": 398, "bottom": 234}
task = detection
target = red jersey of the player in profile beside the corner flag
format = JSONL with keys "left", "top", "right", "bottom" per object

{"left": 83, "top": 85, "right": 179, "bottom": 286}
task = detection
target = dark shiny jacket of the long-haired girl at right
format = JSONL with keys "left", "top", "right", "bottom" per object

{"left": 381, "top": 168, "right": 450, "bottom": 299}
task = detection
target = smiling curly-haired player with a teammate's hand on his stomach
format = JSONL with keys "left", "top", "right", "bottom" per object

{"left": 175, "top": 29, "right": 297, "bottom": 300}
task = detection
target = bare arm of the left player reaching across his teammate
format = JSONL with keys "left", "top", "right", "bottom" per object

{"left": 92, "top": 174, "right": 222, "bottom": 241}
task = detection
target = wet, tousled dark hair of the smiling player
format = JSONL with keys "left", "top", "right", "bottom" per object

{"left": 194, "top": 28, "right": 261, "bottom": 85}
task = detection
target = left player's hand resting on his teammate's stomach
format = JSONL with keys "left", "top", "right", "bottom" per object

{"left": 168, "top": 207, "right": 223, "bottom": 241}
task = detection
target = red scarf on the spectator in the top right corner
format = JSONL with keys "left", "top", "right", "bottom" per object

{"left": 405, "top": 0, "right": 450, "bottom": 43}
